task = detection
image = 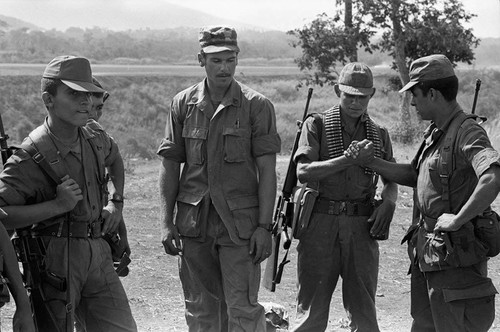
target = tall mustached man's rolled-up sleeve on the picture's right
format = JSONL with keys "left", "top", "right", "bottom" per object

{"left": 252, "top": 99, "right": 281, "bottom": 157}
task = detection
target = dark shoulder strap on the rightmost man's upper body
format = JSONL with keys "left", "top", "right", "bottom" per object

{"left": 438, "top": 112, "right": 477, "bottom": 212}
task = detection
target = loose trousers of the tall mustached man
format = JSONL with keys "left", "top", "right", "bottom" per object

{"left": 179, "top": 206, "right": 266, "bottom": 332}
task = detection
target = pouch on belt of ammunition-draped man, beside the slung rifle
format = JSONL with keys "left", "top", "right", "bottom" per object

{"left": 292, "top": 184, "right": 319, "bottom": 239}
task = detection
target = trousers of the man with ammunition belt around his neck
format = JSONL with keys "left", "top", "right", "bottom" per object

{"left": 292, "top": 213, "right": 379, "bottom": 332}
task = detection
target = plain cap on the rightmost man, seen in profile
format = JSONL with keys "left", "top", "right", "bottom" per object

{"left": 399, "top": 54, "right": 455, "bottom": 92}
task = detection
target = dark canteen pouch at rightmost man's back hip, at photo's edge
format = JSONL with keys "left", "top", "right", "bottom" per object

{"left": 472, "top": 211, "right": 500, "bottom": 257}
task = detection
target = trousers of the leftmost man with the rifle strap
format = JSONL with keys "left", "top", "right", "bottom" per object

{"left": 42, "top": 236, "right": 137, "bottom": 332}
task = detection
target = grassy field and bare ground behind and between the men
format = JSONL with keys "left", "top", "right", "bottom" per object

{"left": 0, "top": 64, "right": 500, "bottom": 332}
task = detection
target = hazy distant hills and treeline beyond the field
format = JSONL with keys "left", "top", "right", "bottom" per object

{"left": 0, "top": 11, "right": 500, "bottom": 68}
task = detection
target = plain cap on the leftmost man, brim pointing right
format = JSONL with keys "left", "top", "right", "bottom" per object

{"left": 43, "top": 55, "right": 104, "bottom": 92}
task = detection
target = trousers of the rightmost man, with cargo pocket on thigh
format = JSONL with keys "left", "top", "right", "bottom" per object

{"left": 411, "top": 261, "right": 496, "bottom": 332}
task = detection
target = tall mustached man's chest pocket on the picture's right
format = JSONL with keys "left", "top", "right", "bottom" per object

{"left": 222, "top": 127, "right": 251, "bottom": 163}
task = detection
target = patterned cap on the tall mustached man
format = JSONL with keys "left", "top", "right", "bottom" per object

{"left": 199, "top": 27, "right": 240, "bottom": 53}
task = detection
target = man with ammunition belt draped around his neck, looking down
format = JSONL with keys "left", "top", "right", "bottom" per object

{"left": 292, "top": 62, "right": 397, "bottom": 332}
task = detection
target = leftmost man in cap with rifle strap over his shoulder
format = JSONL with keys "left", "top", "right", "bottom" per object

{"left": 0, "top": 56, "right": 137, "bottom": 332}
